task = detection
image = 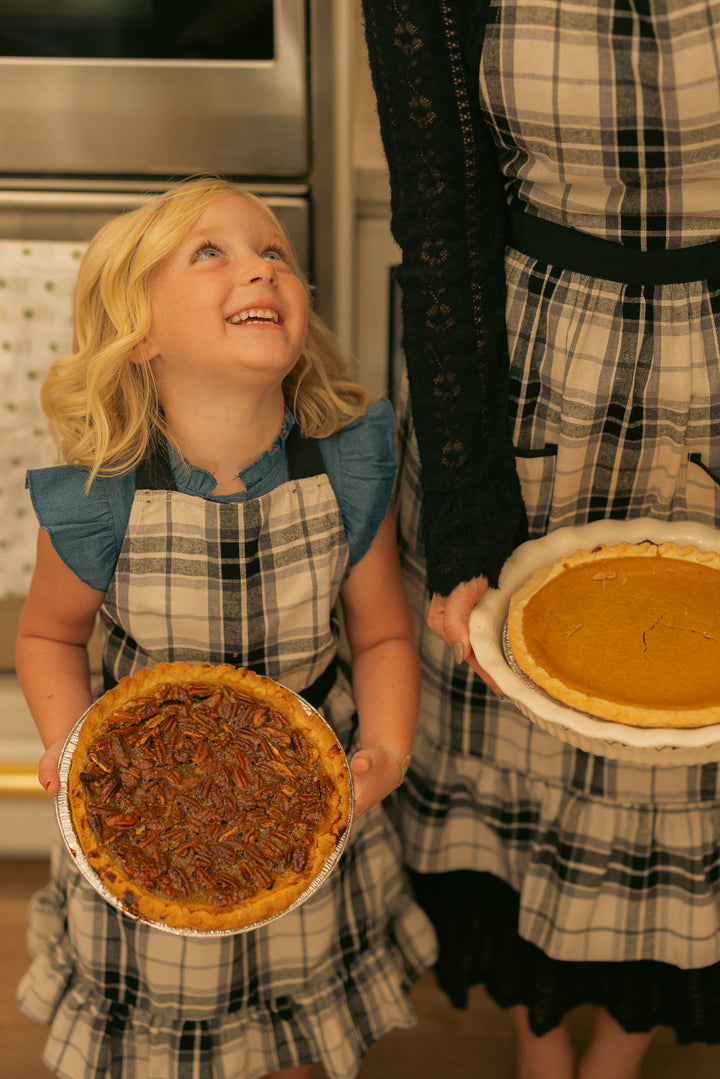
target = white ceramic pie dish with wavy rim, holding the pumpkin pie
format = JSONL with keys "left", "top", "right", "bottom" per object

{"left": 470, "top": 517, "right": 720, "bottom": 765}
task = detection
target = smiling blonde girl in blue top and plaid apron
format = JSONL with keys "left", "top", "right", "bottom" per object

{"left": 17, "top": 179, "right": 434, "bottom": 1079}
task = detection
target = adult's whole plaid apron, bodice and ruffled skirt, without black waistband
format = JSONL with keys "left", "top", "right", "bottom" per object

{"left": 398, "top": 0, "right": 720, "bottom": 1040}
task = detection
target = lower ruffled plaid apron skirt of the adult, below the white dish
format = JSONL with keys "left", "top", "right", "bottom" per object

{"left": 398, "top": 364, "right": 720, "bottom": 969}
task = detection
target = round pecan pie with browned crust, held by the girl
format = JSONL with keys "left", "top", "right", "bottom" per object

{"left": 68, "top": 663, "right": 350, "bottom": 931}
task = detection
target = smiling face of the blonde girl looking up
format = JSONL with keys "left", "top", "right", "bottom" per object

{"left": 146, "top": 195, "right": 309, "bottom": 388}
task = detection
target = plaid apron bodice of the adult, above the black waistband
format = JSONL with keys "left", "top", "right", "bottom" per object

{"left": 480, "top": 0, "right": 720, "bottom": 250}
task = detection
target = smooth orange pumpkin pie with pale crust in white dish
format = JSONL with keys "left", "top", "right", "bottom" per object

{"left": 507, "top": 543, "right": 720, "bottom": 727}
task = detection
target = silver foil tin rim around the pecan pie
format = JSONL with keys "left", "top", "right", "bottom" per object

{"left": 55, "top": 682, "right": 354, "bottom": 938}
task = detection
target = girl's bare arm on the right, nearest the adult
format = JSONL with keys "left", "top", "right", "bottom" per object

{"left": 341, "top": 509, "right": 420, "bottom": 818}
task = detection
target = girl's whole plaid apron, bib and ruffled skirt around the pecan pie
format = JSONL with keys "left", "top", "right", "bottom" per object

{"left": 18, "top": 435, "right": 435, "bottom": 1079}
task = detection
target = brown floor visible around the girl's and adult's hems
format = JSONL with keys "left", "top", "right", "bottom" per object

{"left": 0, "top": 860, "right": 720, "bottom": 1079}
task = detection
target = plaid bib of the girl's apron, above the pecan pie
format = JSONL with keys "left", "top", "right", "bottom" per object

{"left": 100, "top": 476, "right": 348, "bottom": 692}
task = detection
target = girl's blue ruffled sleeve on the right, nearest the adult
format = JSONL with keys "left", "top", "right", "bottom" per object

{"left": 317, "top": 397, "right": 397, "bottom": 565}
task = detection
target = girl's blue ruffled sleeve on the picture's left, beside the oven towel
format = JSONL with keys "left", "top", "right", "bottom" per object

{"left": 26, "top": 465, "right": 134, "bottom": 592}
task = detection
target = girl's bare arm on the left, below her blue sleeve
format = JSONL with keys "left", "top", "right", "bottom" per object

{"left": 15, "top": 529, "right": 105, "bottom": 794}
